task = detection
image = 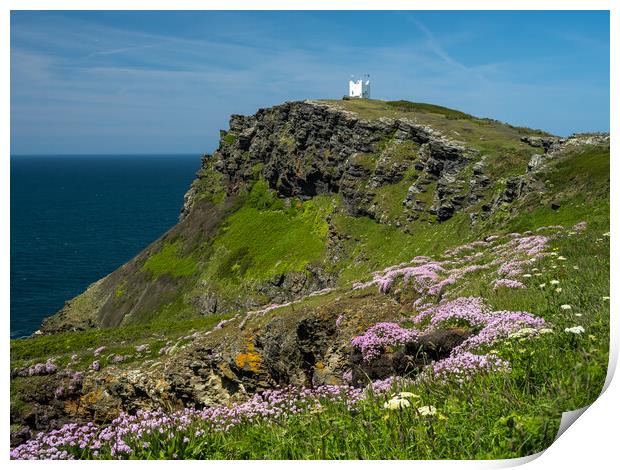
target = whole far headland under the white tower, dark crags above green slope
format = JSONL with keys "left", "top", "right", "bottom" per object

{"left": 37, "top": 101, "right": 608, "bottom": 333}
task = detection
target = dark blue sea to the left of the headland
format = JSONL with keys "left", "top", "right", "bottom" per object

{"left": 11, "top": 155, "right": 200, "bottom": 337}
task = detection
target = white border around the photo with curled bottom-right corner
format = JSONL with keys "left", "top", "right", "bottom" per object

{"left": 0, "top": 0, "right": 620, "bottom": 470}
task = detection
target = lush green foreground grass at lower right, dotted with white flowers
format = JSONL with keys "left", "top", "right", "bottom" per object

{"left": 15, "top": 194, "right": 609, "bottom": 459}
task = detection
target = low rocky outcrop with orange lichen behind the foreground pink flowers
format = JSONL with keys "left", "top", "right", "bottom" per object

{"left": 12, "top": 293, "right": 418, "bottom": 444}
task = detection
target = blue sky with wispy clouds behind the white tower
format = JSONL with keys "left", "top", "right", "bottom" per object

{"left": 11, "top": 11, "right": 609, "bottom": 154}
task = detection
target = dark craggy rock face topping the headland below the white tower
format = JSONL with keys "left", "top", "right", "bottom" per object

{"left": 182, "top": 102, "right": 472, "bottom": 220}
